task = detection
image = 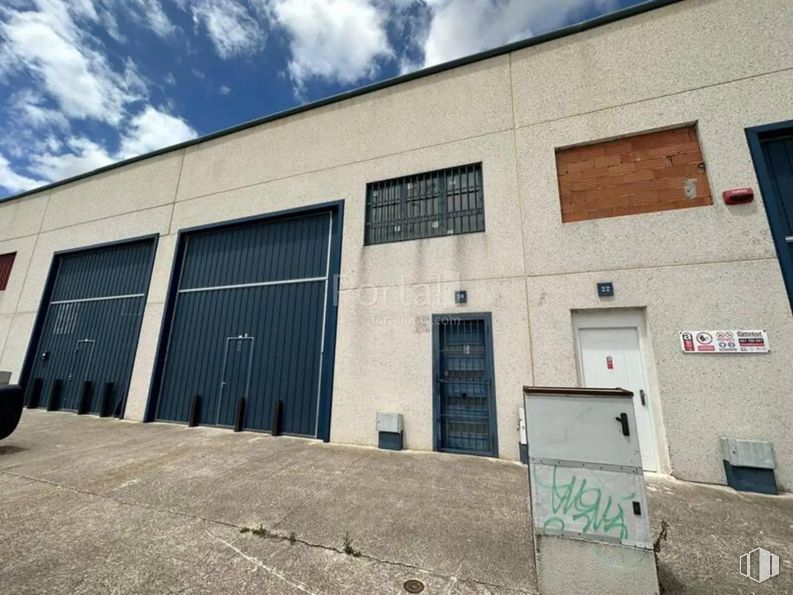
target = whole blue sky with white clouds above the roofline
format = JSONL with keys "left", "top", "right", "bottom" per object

{"left": 0, "top": 0, "right": 641, "bottom": 198}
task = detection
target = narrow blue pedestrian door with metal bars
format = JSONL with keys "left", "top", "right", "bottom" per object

{"left": 433, "top": 314, "right": 498, "bottom": 456}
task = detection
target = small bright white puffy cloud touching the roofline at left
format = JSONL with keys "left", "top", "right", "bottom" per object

{"left": 118, "top": 106, "right": 196, "bottom": 159}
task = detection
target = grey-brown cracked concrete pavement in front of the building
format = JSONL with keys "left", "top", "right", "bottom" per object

{"left": 0, "top": 411, "right": 793, "bottom": 595}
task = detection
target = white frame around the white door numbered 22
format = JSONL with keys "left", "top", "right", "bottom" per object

{"left": 572, "top": 308, "right": 668, "bottom": 472}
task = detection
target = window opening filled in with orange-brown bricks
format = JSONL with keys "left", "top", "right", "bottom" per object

{"left": 556, "top": 126, "right": 713, "bottom": 223}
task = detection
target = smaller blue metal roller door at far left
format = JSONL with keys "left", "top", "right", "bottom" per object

{"left": 27, "top": 239, "right": 155, "bottom": 415}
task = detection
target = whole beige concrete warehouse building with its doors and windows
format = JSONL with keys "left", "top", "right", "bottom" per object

{"left": 0, "top": 0, "right": 793, "bottom": 489}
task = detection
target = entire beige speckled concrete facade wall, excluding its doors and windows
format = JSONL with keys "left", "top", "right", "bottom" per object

{"left": 0, "top": 0, "right": 793, "bottom": 487}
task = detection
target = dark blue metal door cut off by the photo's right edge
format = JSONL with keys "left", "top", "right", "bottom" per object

{"left": 750, "top": 126, "right": 793, "bottom": 307}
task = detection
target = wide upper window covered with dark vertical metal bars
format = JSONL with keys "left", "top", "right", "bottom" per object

{"left": 365, "top": 163, "right": 485, "bottom": 245}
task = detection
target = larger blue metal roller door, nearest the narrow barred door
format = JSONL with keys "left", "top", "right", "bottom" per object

{"left": 155, "top": 211, "right": 335, "bottom": 436}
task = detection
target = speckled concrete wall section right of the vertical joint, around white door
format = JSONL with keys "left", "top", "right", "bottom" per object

{"left": 513, "top": 0, "right": 793, "bottom": 489}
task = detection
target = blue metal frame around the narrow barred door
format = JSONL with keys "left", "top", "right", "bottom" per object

{"left": 432, "top": 312, "right": 498, "bottom": 457}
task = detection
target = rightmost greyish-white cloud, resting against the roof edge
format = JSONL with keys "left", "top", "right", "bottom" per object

{"left": 417, "top": 0, "right": 617, "bottom": 66}
